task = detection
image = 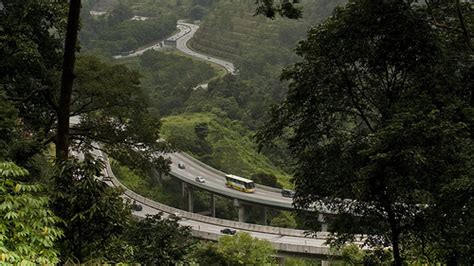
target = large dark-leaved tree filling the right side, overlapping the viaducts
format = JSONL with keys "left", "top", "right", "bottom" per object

{"left": 258, "top": 0, "right": 474, "bottom": 265}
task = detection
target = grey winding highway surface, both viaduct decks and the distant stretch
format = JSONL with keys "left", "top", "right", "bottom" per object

{"left": 105, "top": 21, "right": 331, "bottom": 256}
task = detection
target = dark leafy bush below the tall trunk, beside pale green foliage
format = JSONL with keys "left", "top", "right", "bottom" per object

{"left": 52, "top": 155, "right": 131, "bottom": 262}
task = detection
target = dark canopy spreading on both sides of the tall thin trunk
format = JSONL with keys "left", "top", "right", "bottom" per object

{"left": 0, "top": 1, "right": 168, "bottom": 171}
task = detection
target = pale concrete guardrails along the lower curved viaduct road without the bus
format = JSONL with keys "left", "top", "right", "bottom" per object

{"left": 106, "top": 158, "right": 332, "bottom": 255}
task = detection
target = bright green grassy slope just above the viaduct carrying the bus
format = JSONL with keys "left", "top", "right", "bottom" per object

{"left": 162, "top": 113, "right": 291, "bottom": 187}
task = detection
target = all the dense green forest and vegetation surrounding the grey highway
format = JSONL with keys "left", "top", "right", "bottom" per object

{"left": 0, "top": 0, "right": 474, "bottom": 266}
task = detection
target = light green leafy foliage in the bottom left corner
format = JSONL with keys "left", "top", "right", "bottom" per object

{"left": 0, "top": 162, "right": 63, "bottom": 265}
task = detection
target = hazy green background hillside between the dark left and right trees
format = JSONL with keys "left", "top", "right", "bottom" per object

{"left": 75, "top": 0, "right": 344, "bottom": 187}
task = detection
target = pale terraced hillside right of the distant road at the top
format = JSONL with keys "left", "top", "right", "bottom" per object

{"left": 191, "top": 0, "right": 345, "bottom": 77}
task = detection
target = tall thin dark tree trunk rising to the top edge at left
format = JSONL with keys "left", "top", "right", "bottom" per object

{"left": 56, "top": 0, "right": 81, "bottom": 160}
